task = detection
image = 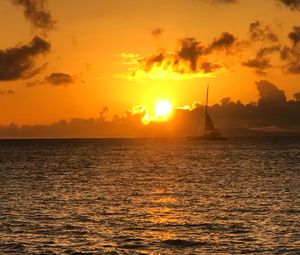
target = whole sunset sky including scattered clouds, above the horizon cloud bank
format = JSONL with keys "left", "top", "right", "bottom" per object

{"left": 0, "top": 0, "right": 300, "bottom": 124}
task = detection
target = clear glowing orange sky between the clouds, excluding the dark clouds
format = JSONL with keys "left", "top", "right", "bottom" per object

{"left": 0, "top": 0, "right": 300, "bottom": 124}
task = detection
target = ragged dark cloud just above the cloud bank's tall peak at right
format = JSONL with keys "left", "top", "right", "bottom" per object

{"left": 242, "top": 45, "right": 281, "bottom": 75}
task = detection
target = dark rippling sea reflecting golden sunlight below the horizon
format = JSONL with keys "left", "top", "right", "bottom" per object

{"left": 0, "top": 138, "right": 300, "bottom": 255}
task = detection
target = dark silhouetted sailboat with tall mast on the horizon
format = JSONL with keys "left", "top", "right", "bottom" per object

{"left": 187, "top": 86, "right": 226, "bottom": 141}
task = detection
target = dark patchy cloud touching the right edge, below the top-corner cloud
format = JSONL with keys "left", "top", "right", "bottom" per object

{"left": 280, "top": 26, "right": 300, "bottom": 74}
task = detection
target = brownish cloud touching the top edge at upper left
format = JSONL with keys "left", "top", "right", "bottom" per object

{"left": 11, "top": 0, "right": 55, "bottom": 32}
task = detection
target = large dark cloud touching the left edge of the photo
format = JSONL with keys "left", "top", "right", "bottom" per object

{"left": 0, "top": 36, "right": 50, "bottom": 81}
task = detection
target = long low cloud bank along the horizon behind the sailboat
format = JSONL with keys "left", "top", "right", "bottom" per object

{"left": 0, "top": 80, "right": 300, "bottom": 138}
